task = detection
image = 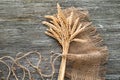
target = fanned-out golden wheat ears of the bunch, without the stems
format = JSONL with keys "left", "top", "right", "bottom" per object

{"left": 42, "top": 4, "right": 91, "bottom": 47}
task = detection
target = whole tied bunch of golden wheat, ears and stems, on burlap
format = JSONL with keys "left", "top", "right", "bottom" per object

{"left": 42, "top": 4, "right": 91, "bottom": 80}
